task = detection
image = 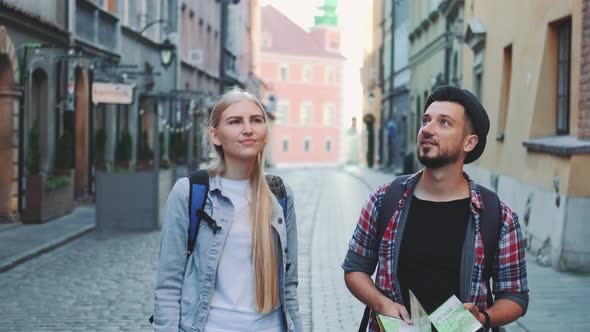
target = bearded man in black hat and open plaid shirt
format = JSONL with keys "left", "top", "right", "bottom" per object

{"left": 342, "top": 86, "right": 528, "bottom": 331}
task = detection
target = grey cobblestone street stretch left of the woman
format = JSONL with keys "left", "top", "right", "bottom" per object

{"left": 0, "top": 232, "right": 160, "bottom": 331}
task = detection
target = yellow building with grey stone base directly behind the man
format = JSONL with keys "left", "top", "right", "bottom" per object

{"left": 462, "top": 0, "right": 590, "bottom": 271}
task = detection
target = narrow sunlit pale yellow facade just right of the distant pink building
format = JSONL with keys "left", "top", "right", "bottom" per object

{"left": 360, "top": 0, "right": 383, "bottom": 167}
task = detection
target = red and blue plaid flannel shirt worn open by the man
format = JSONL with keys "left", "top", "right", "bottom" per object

{"left": 343, "top": 171, "right": 528, "bottom": 332}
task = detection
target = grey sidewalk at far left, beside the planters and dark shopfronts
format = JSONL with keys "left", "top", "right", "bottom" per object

{"left": 0, "top": 205, "right": 95, "bottom": 273}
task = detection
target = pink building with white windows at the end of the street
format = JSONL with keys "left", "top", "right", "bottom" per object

{"left": 261, "top": 1, "right": 344, "bottom": 167}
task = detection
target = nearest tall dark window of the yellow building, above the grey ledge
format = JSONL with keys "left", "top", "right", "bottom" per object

{"left": 557, "top": 19, "right": 572, "bottom": 135}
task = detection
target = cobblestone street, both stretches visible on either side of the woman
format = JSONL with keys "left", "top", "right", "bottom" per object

{"left": 0, "top": 169, "right": 369, "bottom": 331}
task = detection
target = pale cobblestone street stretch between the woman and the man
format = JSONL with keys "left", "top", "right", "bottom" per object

{"left": 279, "top": 169, "right": 369, "bottom": 332}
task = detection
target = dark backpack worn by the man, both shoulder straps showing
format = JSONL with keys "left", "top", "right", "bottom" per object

{"left": 359, "top": 175, "right": 502, "bottom": 332}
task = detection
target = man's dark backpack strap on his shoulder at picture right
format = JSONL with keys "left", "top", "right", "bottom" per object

{"left": 477, "top": 185, "right": 502, "bottom": 307}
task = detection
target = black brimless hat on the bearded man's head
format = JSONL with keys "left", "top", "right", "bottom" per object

{"left": 424, "top": 85, "right": 490, "bottom": 164}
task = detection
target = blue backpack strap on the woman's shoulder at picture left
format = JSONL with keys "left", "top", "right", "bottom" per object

{"left": 187, "top": 169, "right": 209, "bottom": 256}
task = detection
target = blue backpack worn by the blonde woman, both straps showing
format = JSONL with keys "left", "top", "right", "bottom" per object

{"left": 149, "top": 169, "right": 287, "bottom": 324}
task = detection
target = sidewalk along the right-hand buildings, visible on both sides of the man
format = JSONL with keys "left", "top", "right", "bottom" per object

{"left": 344, "top": 167, "right": 590, "bottom": 332}
